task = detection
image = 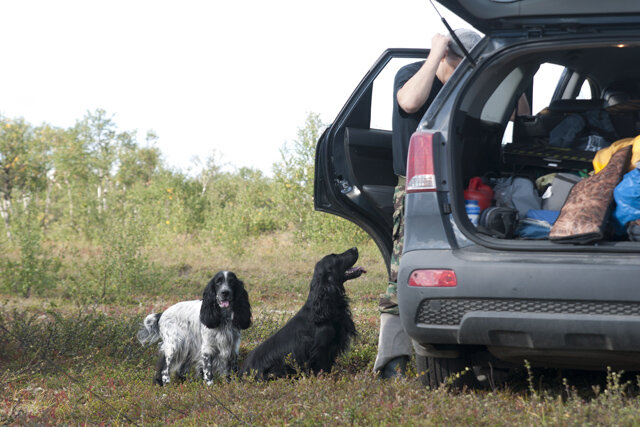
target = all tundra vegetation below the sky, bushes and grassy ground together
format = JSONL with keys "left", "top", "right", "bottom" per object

{"left": 0, "top": 110, "right": 640, "bottom": 425}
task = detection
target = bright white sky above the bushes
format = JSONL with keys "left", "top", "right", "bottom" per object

{"left": 0, "top": 0, "right": 470, "bottom": 173}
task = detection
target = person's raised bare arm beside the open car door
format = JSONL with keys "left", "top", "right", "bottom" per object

{"left": 396, "top": 34, "right": 449, "bottom": 114}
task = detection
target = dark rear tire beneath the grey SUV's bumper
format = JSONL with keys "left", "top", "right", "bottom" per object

{"left": 416, "top": 354, "right": 479, "bottom": 389}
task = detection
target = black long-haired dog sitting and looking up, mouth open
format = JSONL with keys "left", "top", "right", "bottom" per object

{"left": 241, "top": 248, "right": 365, "bottom": 379}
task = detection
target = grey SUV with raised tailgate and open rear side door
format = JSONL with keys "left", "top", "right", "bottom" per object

{"left": 315, "top": 0, "right": 640, "bottom": 385}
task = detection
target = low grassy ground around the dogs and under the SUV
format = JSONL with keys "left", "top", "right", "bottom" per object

{"left": 0, "top": 234, "right": 640, "bottom": 426}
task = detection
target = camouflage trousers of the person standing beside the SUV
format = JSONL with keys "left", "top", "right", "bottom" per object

{"left": 378, "top": 177, "right": 405, "bottom": 315}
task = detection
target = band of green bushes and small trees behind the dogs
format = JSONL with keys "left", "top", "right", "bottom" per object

{"left": 0, "top": 110, "right": 376, "bottom": 301}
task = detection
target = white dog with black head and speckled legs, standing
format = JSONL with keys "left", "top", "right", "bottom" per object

{"left": 138, "top": 271, "right": 251, "bottom": 385}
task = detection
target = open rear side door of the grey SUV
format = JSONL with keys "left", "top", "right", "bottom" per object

{"left": 314, "top": 49, "right": 429, "bottom": 266}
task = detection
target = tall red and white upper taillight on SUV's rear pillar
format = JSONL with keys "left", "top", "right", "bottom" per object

{"left": 405, "top": 132, "right": 436, "bottom": 193}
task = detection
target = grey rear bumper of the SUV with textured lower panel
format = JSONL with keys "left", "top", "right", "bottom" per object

{"left": 398, "top": 246, "right": 640, "bottom": 368}
